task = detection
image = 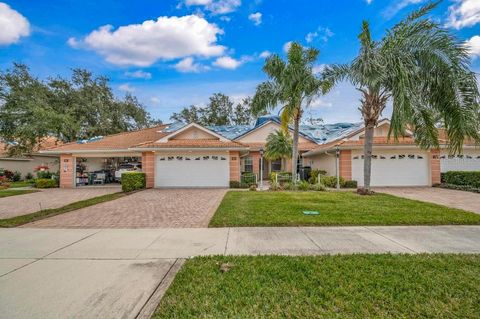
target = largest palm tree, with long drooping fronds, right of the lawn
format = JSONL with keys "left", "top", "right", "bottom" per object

{"left": 323, "top": 2, "right": 480, "bottom": 194}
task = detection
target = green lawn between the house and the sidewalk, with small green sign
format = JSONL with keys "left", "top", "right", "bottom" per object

{"left": 210, "top": 191, "right": 480, "bottom": 227}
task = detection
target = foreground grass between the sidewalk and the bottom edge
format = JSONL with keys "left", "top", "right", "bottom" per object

{"left": 153, "top": 255, "right": 480, "bottom": 319}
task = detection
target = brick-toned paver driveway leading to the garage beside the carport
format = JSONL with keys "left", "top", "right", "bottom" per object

{"left": 23, "top": 189, "right": 227, "bottom": 228}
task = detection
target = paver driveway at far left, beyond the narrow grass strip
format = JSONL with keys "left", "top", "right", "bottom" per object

{"left": 0, "top": 186, "right": 121, "bottom": 219}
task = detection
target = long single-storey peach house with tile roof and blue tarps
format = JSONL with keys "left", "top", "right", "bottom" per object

{"left": 41, "top": 116, "right": 480, "bottom": 188}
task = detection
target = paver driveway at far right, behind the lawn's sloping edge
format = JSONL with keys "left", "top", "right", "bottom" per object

{"left": 374, "top": 187, "right": 480, "bottom": 214}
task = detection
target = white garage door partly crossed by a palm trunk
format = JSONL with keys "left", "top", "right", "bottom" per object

{"left": 352, "top": 150, "right": 430, "bottom": 186}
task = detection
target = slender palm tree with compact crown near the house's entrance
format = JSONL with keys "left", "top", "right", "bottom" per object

{"left": 252, "top": 43, "right": 328, "bottom": 182}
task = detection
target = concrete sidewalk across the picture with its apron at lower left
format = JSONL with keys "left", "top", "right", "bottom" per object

{"left": 0, "top": 226, "right": 480, "bottom": 318}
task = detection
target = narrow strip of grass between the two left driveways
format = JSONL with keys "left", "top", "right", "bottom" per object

{"left": 0, "top": 192, "right": 127, "bottom": 228}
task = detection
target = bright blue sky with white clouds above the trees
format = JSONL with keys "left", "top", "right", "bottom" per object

{"left": 0, "top": 0, "right": 480, "bottom": 123}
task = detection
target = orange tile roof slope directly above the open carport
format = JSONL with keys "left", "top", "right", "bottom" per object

{"left": 43, "top": 125, "right": 167, "bottom": 152}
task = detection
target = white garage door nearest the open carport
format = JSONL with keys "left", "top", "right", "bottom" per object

{"left": 155, "top": 153, "right": 230, "bottom": 187}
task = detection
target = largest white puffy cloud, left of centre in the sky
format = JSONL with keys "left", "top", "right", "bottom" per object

{"left": 69, "top": 15, "right": 226, "bottom": 66}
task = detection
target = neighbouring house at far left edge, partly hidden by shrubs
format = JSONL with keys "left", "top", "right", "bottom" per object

{"left": 0, "top": 137, "right": 59, "bottom": 178}
